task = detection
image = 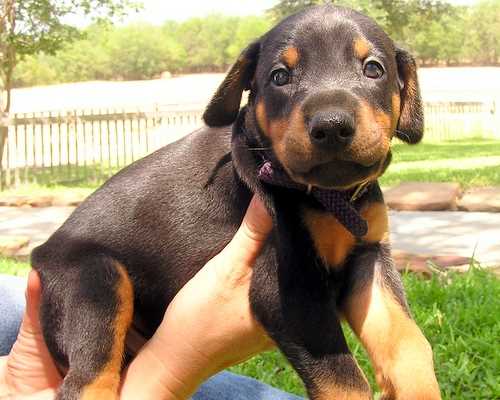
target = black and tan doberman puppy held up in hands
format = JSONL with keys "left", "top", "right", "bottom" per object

{"left": 32, "top": 6, "right": 440, "bottom": 400}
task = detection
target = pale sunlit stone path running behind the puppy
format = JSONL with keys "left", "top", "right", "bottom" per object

{"left": 0, "top": 207, "right": 500, "bottom": 272}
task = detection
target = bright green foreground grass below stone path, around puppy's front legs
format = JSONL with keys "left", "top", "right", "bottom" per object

{"left": 0, "top": 259, "right": 500, "bottom": 400}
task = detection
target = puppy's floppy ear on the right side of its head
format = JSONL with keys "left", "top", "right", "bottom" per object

{"left": 396, "top": 49, "right": 424, "bottom": 144}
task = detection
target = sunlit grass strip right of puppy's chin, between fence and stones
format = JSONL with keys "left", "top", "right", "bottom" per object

{"left": 380, "top": 138, "right": 500, "bottom": 189}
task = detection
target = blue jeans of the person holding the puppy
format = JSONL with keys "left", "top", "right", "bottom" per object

{"left": 0, "top": 275, "right": 302, "bottom": 400}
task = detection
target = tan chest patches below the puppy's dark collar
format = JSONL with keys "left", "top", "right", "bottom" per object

{"left": 302, "top": 202, "right": 389, "bottom": 267}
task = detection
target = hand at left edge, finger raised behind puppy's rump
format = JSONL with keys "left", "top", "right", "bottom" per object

{"left": 0, "top": 271, "right": 62, "bottom": 400}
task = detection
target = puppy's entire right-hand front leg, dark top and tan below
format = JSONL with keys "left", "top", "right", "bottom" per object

{"left": 343, "top": 244, "right": 441, "bottom": 400}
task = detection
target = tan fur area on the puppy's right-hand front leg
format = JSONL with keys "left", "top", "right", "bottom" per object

{"left": 344, "top": 273, "right": 441, "bottom": 400}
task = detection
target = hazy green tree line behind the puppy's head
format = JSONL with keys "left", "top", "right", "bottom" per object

{"left": 9, "top": 0, "right": 500, "bottom": 86}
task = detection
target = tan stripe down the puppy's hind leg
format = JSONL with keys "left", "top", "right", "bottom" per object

{"left": 81, "top": 263, "right": 134, "bottom": 400}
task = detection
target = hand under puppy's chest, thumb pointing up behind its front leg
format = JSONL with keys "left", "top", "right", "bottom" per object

{"left": 121, "top": 197, "right": 273, "bottom": 399}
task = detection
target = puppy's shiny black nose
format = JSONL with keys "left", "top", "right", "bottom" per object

{"left": 309, "top": 110, "right": 356, "bottom": 148}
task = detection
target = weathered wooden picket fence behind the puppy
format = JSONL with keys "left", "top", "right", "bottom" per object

{"left": 0, "top": 103, "right": 500, "bottom": 190}
